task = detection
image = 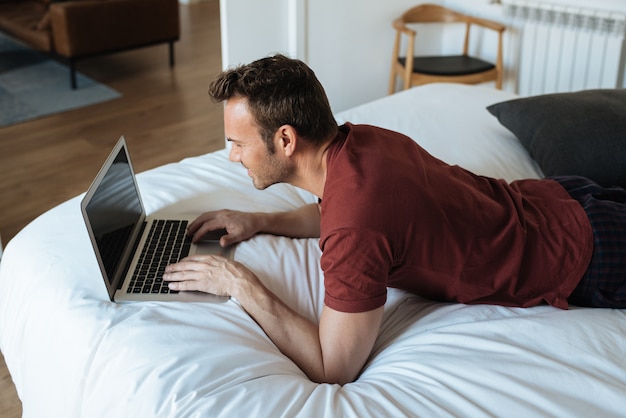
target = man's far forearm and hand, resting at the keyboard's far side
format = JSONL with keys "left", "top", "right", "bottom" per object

{"left": 188, "top": 203, "right": 320, "bottom": 247}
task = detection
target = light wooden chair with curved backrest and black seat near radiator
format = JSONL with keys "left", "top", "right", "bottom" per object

{"left": 389, "top": 4, "right": 505, "bottom": 94}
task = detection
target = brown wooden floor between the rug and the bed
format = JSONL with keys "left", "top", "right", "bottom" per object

{"left": 0, "top": 0, "right": 224, "bottom": 418}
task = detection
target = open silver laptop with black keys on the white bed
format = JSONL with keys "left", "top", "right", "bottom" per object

{"left": 80, "top": 136, "right": 232, "bottom": 302}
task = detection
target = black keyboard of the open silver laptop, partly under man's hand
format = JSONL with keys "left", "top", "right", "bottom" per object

{"left": 127, "top": 220, "right": 191, "bottom": 293}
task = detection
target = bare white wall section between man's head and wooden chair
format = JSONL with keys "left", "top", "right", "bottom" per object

{"left": 307, "top": 0, "right": 419, "bottom": 111}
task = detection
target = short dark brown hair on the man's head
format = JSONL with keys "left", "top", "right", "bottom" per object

{"left": 209, "top": 55, "right": 337, "bottom": 153}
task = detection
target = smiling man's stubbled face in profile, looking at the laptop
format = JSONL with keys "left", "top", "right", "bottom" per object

{"left": 224, "top": 98, "right": 293, "bottom": 190}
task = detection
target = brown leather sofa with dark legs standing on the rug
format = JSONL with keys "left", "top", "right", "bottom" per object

{"left": 0, "top": 0, "right": 180, "bottom": 88}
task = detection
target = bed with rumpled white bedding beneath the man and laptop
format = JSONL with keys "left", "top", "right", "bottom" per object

{"left": 0, "top": 84, "right": 626, "bottom": 417}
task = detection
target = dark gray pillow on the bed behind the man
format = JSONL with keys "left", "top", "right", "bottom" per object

{"left": 487, "top": 89, "right": 626, "bottom": 187}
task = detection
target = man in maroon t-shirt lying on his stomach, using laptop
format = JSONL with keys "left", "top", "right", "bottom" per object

{"left": 164, "top": 55, "right": 626, "bottom": 384}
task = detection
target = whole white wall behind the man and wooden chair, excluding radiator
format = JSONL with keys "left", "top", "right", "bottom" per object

{"left": 220, "top": 0, "right": 626, "bottom": 112}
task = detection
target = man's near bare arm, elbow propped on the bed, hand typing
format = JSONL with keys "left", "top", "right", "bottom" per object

{"left": 163, "top": 255, "right": 383, "bottom": 384}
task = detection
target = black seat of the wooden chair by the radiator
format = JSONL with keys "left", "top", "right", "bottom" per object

{"left": 398, "top": 55, "right": 495, "bottom": 76}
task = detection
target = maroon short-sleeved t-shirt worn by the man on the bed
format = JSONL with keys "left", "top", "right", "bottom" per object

{"left": 320, "top": 124, "right": 593, "bottom": 312}
